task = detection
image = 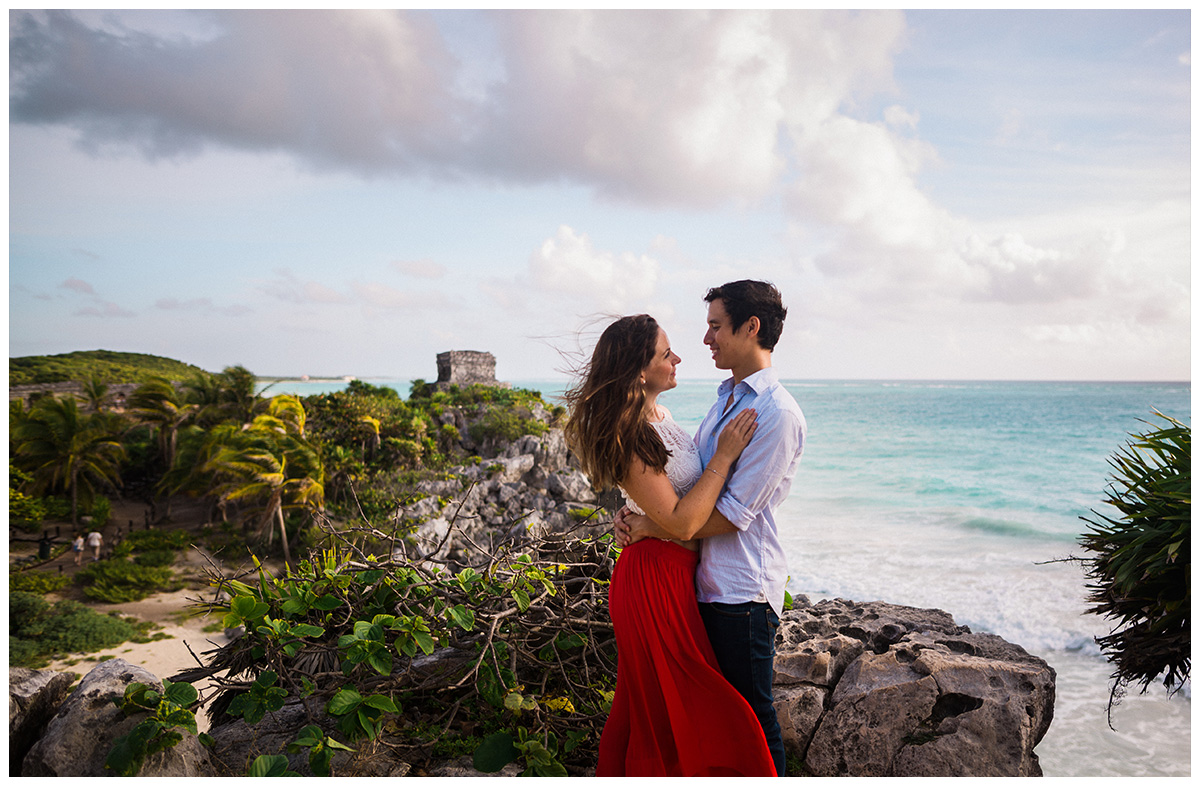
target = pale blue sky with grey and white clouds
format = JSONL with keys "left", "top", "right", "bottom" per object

{"left": 8, "top": 11, "right": 1192, "bottom": 380}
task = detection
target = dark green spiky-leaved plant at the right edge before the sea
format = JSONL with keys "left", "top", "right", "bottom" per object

{"left": 1080, "top": 410, "right": 1192, "bottom": 710}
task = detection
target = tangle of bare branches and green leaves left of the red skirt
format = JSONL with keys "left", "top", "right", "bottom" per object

{"left": 184, "top": 515, "right": 617, "bottom": 776}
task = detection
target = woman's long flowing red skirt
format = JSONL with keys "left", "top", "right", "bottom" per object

{"left": 596, "top": 539, "right": 775, "bottom": 777}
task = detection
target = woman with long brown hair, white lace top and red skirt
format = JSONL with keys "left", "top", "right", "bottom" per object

{"left": 565, "top": 314, "right": 775, "bottom": 777}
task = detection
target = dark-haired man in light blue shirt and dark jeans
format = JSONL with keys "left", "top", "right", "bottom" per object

{"left": 617, "top": 279, "right": 806, "bottom": 776}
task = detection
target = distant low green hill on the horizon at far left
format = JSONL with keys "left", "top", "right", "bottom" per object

{"left": 8, "top": 350, "right": 211, "bottom": 386}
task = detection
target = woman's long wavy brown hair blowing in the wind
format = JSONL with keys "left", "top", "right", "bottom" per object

{"left": 563, "top": 314, "right": 667, "bottom": 489}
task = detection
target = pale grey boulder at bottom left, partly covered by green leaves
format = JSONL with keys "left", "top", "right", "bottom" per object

{"left": 20, "top": 660, "right": 216, "bottom": 777}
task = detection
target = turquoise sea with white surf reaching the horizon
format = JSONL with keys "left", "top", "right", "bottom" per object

{"left": 258, "top": 380, "right": 1192, "bottom": 777}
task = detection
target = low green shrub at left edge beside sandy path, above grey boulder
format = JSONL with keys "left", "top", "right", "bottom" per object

{"left": 8, "top": 591, "right": 152, "bottom": 668}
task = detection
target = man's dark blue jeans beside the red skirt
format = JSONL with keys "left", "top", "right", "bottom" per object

{"left": 700, "top": 602, "right": 787, "bottom": 777}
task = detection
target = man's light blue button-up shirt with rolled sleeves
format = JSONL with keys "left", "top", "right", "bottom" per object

{"left": 696, "top": 367, "right": 808, "bottom": 614}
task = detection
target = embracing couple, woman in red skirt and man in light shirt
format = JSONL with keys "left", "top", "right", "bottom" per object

{"left": 566, "top": 279, "right": 805, "bottom": 776}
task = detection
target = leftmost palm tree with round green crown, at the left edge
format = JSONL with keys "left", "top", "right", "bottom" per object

{"left": 13, "top": 396, "right": 125, "bottom": 525}
